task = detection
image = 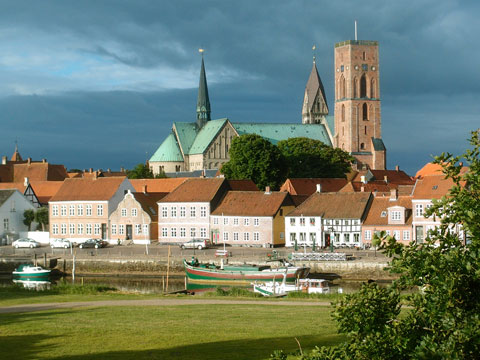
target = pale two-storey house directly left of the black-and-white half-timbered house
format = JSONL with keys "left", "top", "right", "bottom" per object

{"left": 210, "top": 187, "right": 295, "bottom": 247}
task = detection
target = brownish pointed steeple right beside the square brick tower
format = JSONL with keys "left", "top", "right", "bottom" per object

{"left": 302, "top": 51, "right": 328, "bottom": 124}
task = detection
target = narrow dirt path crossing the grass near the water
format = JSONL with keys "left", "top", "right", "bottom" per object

{"left": 0, "top": 299, "right": 330, "bottom": 314}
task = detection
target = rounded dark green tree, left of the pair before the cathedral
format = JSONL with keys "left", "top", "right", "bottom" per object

{"left": 221, "top": 134, "right": 287, "bottom": 189}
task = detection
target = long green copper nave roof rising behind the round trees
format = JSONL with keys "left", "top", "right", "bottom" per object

{"left": 232, "top": 123, "right": 332, "bottom": 146}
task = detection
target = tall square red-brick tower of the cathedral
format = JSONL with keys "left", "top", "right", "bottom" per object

{"left": 333, "top": 40, "right": 387, "bottom": 170}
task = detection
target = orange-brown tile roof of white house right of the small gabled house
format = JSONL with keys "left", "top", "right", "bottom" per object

{"left": 160, "top": 178, "right": 228, "bottom": 202}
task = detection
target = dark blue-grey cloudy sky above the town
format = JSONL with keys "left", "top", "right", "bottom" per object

{"left": 0, "top": 0, "right": 480, "bottom": 175}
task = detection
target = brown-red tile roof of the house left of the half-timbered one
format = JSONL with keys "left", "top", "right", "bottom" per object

{"left": 212, "top": 191, "right": 293, "bottom": 216}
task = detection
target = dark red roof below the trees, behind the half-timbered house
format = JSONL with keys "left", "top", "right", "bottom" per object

{"left": 280, "top": 178, "right": 347, "bottom": 195}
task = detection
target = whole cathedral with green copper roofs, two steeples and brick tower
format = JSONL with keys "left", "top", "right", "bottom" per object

{"left": 149, "top": 40, "right": 386, "bottom": 174}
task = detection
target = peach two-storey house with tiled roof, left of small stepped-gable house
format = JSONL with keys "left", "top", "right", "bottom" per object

{"left": 49, "top": 177, "right": 134, "bottom": 242}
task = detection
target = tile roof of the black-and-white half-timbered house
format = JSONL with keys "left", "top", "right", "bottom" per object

{"left": 288, "top": 192, "right": 373, "bottom": 219}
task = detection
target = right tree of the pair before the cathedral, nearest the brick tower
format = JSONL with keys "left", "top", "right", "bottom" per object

{"left": 278, "top": 137, "right": 354, "bottom": 178}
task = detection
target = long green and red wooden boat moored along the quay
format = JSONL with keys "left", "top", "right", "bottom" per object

{"left": 183, "top": 259, "right": 310, "bottom": 284}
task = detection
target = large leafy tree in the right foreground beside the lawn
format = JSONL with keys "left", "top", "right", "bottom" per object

{"left": 276, "top": 132, "right": 480, "bottom": 360}
